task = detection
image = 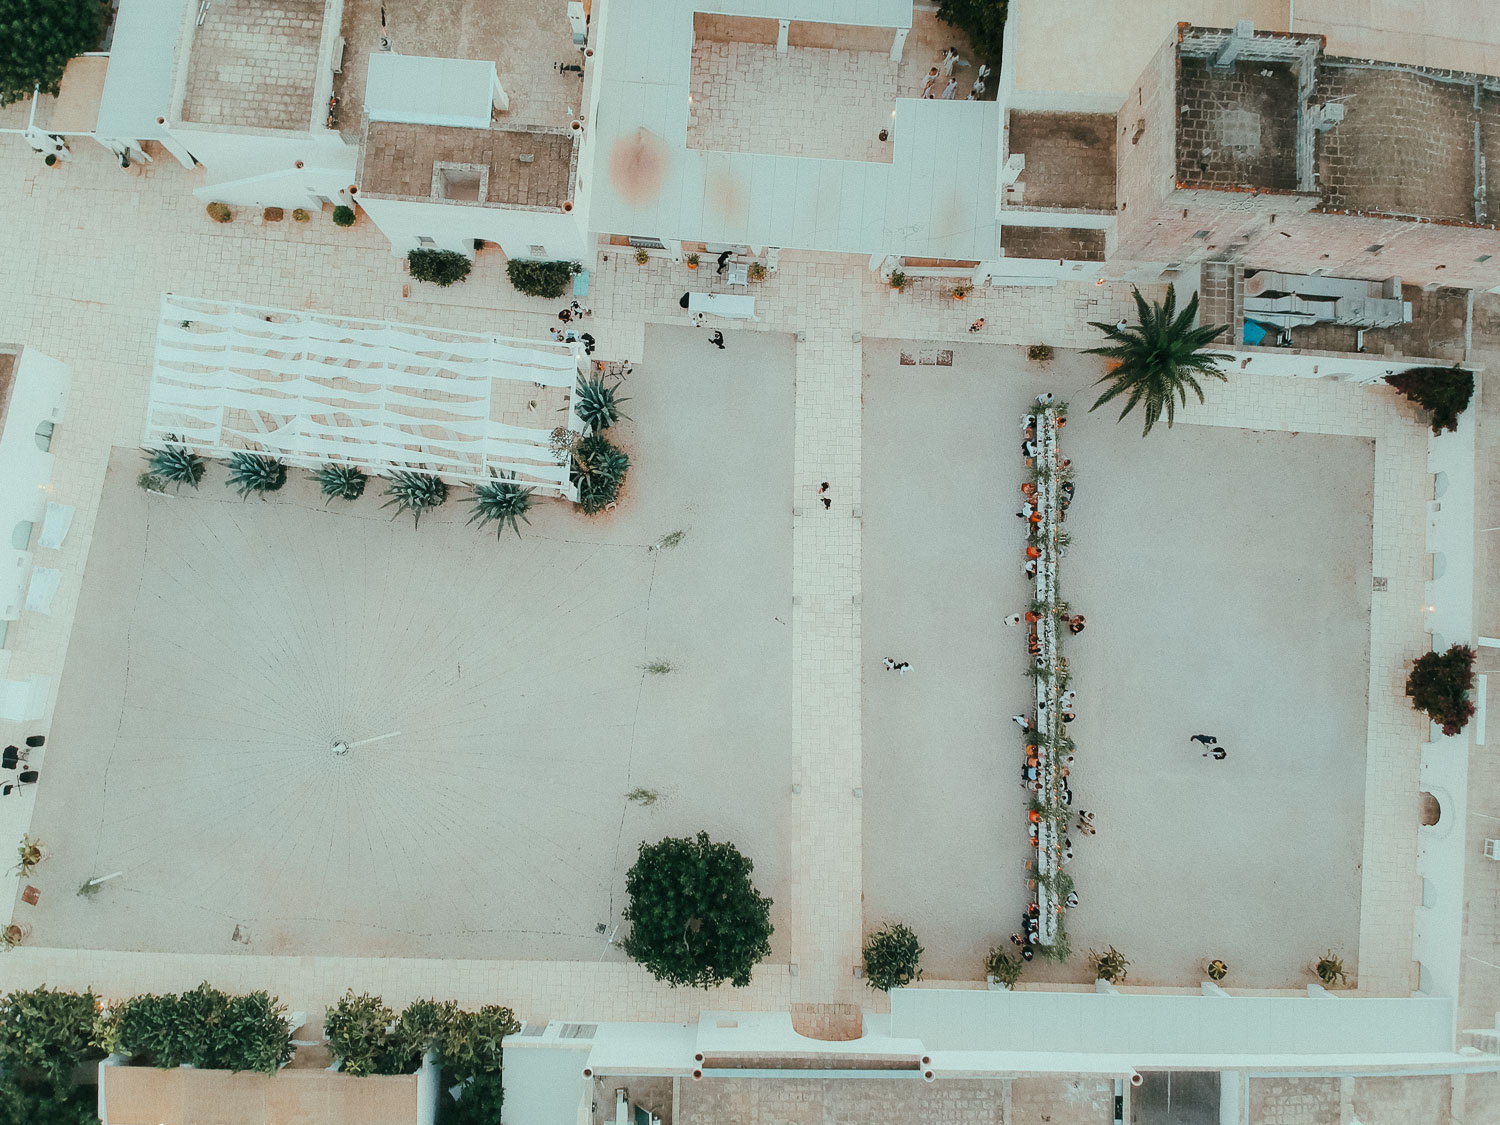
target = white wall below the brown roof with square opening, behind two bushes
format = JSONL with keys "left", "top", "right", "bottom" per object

{"left": 359, "top": 195, "right": 588, "bottom": 261}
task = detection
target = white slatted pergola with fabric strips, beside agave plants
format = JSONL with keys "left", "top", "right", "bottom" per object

{"left": 146, "top": 294, "right": 582, "bottom": 498}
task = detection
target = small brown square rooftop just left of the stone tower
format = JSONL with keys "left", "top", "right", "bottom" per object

{"left": 1007, "top": 110, "right": 1115, "bottom": 213}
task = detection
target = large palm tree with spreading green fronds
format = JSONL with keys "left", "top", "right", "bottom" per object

{"left": 1085, "top": 285, "right": 1235, "bottom": 437}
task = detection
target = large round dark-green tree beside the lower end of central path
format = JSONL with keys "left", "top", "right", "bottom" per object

{"left": 623, "top": 833, "right": 771, "bottom": 989}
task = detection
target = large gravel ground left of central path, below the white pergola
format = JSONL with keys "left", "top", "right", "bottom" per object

{"left": 23, "top": 329, "right": 794, "bottom": 959}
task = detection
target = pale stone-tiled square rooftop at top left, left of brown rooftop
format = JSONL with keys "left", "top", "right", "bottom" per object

{"left": 179, "top": 0, "right": 326, "bottom": 129}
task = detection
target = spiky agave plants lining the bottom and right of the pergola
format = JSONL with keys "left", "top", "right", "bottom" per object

{"left": 137, "top": 377, "right": 630, "bottom": 536}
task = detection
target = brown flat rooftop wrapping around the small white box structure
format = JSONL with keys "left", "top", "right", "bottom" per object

{"left": 333, "top": 0, "right": 584, "bottom": 129}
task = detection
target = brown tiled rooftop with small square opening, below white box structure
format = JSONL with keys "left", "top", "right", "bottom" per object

{"left": 360, "top": 122, "right": 575, "bottom": 209}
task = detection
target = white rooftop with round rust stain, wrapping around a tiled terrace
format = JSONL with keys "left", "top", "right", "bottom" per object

{"left": 590, "top": 0, "right": 1001, "bottom": 260}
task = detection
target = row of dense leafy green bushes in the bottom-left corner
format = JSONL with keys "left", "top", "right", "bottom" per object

{"left": 0, "top": 984, "right": 521, "bottom": 1125}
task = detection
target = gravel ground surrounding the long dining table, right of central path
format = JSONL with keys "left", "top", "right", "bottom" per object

{"left": 864, "top": 341, "right": 1374, "bottom": 987}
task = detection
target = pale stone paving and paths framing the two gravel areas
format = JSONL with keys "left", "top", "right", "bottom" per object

{"left": 0, "top": 127, "right": 1428, "bottom": 1038}
